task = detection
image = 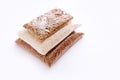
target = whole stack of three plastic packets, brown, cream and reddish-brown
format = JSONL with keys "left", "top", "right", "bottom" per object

{"left": 16, "top": 9, "right": 83, "bottom": 66}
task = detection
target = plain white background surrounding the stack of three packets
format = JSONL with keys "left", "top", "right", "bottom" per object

{"left": 0, "top": 0, "right": 120, "bottom": 80}
